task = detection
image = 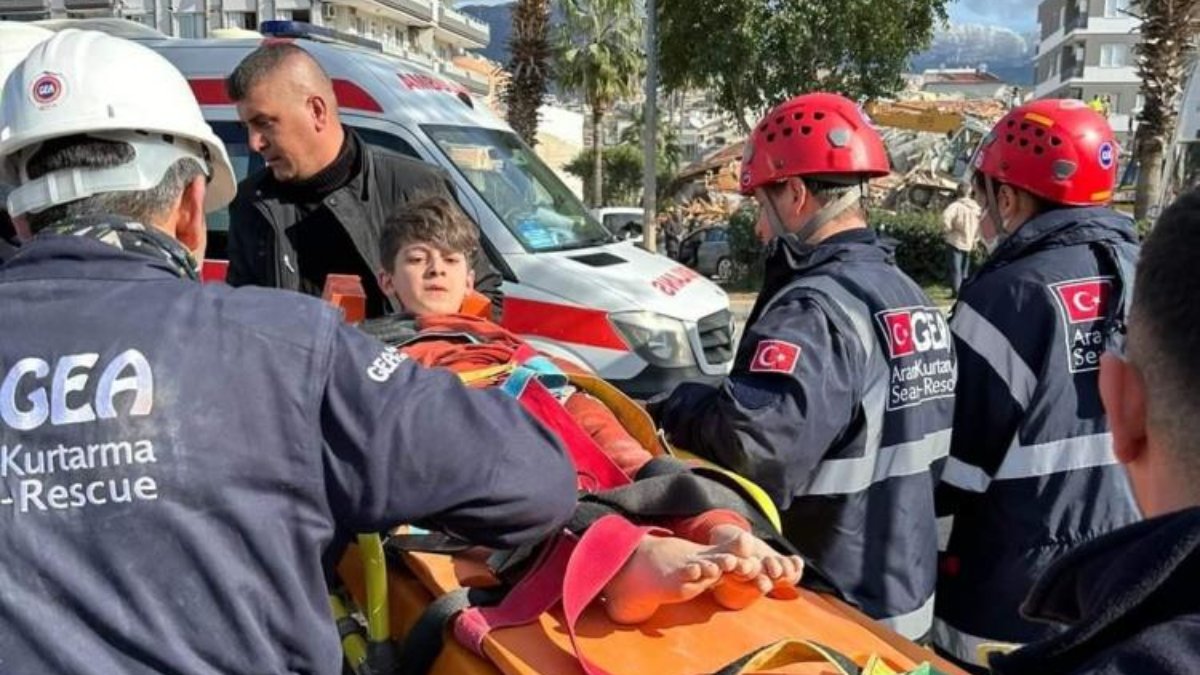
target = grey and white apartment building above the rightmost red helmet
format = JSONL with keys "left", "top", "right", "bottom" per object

{"left": 1033, "top": 0, "right": 1142, "bottom": 142}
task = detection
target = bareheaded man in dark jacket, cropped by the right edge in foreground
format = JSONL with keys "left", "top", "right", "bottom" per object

{"left": 991, "top": 187, "right": 1200, "bottom": 675}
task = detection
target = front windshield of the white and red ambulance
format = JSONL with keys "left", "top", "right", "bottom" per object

{"left": 424, "top": 126, "right": 613, "bottom": 252}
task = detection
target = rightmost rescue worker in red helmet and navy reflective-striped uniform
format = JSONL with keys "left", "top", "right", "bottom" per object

{"left": 934, "top": 100, "right": 1139, "bottom": 664}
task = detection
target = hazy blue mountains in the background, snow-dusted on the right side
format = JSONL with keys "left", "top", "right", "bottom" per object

{"left": 458, "top": 4, "right": 1037, "bottom": 85}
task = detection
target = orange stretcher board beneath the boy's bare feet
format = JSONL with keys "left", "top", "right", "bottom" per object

{"left": 338, "top": 535, "right": 961, "bottom": 675}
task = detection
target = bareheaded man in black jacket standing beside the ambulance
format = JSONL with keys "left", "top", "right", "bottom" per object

{"left": 227, "top": 43, "right": 503, "bottom": 321}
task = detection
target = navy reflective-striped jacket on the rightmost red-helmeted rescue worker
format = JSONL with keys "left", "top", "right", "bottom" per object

{"left": 934, "top": 208, "right": 1139, "bottom": 663}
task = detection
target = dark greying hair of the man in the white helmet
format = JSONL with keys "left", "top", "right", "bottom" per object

{"left": 25, "top": 136, "right": 204, "bottom": 232}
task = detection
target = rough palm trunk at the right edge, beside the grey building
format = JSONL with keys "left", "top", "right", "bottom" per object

{"left": 1133, "top": 0, "right": 1200, "bottom": 219}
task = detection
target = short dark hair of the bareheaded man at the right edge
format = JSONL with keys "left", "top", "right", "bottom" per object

{"left": 1129, "top": 183, "right": 1200, "bottom": 468}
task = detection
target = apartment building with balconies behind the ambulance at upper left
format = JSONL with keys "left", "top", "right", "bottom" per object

{"left": 0, "top": 0, "right": 498, "bottom": 96}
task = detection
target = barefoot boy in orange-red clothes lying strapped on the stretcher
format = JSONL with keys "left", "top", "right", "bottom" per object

{"left": 364, "top": 197, "right": 803, "bottom": 623}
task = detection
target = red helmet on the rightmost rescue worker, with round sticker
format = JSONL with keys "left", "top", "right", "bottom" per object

{"left": 974, "top": 98, "right": 1117, "bottom": 207}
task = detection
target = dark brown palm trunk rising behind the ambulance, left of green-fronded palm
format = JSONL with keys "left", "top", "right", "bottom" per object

{"left": 504, "top": 0, "right": 551, "bottom": 148}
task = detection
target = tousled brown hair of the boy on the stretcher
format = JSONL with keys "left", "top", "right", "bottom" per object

{"left": 379, "top": 195, "right": 479, "bottom": 271}
